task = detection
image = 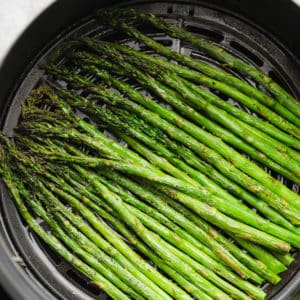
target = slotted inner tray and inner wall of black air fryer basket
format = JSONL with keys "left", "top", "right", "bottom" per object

{"left": 0, "top": 1, "right": 300, "bottom": 299}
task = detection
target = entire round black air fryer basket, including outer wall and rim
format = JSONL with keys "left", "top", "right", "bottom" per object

{"left": 0, "top": 1, "right": 300, "bottom": 300}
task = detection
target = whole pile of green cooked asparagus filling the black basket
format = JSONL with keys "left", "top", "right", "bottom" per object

{"left": 0, "top": 10, "right": 300, "bottom": 300}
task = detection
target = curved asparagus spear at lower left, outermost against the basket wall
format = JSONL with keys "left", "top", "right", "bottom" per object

{"left": 1, "top": 149, "right": 129, "bottom": 300}
